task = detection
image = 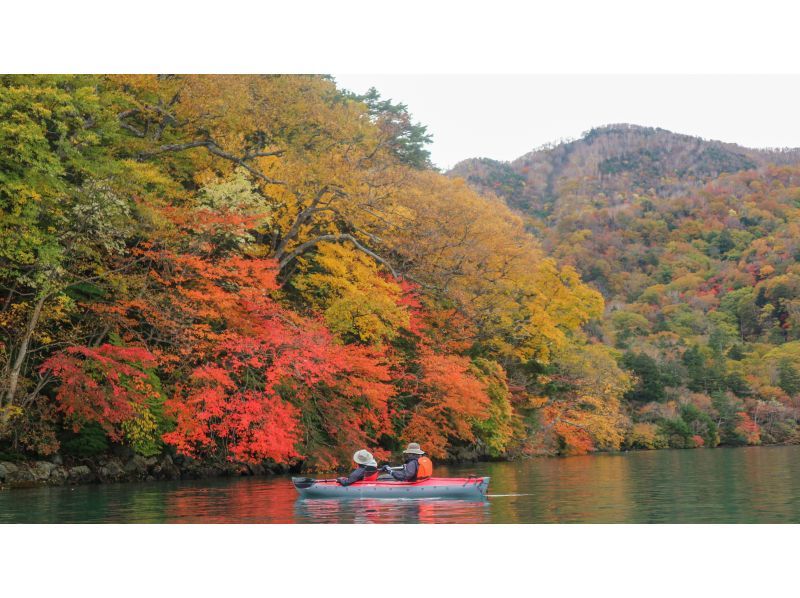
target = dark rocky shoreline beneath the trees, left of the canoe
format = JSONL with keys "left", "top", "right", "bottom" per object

{"left": 0, "top": 455, "right": 288, "bottom": 489}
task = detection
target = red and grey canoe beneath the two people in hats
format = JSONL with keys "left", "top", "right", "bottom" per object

{"left": 292, "top": 476, "right": 489, "bottom": 499}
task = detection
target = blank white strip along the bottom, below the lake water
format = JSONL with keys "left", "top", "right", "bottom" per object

{"left": 0, "top": 525, "right": 797, "bottom": 598}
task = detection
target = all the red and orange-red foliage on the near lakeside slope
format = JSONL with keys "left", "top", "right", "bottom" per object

{"left": 52, "top": 197, "right": 489, "bottom": 469}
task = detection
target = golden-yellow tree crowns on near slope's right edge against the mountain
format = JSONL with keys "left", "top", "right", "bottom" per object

{"left": 392, "top": 172, "right": 603, "bottom": 362}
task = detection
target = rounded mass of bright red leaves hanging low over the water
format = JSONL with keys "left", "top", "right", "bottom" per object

{"left": 164, "top": 318, "right": 394, "bottom": 467}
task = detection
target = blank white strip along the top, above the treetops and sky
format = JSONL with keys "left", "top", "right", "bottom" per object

{"left": 0, "top": 0, "right": 800, "bottom": 74}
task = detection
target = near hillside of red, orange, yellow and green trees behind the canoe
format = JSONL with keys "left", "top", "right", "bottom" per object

{"left": 0, "top": 75, "right": 628, "bottom": 470}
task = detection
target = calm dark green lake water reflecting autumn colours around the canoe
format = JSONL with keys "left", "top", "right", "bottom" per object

{"left": 0, "top": 446, "right": 800, "bottom": 523}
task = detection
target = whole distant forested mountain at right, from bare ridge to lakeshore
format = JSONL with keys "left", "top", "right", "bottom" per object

{"left": 450, "top": 125, "right": 800, "bottom": 447}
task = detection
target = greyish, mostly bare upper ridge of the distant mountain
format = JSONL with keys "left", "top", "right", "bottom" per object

{"left": 450, "top": 124, "right": 800, "bottom": 216}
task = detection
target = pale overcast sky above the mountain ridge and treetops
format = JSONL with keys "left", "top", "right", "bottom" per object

{"left": 335, "top": 75, "right": 800, "bottom": 169}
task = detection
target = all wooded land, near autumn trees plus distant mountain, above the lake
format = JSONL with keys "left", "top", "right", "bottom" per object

{"left": 0, "top": 75, "right": 800, "bottom": 485}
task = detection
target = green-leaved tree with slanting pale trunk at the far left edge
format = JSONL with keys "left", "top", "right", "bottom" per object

{"left": 0, "top": 76, "right": 152, "bottom": 430}
